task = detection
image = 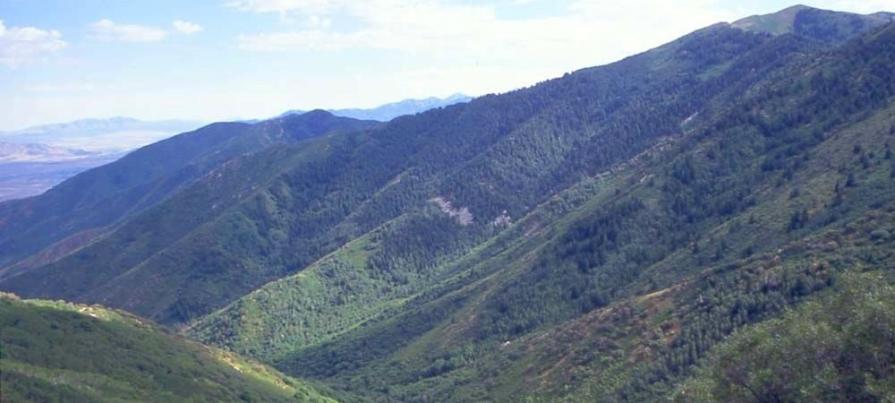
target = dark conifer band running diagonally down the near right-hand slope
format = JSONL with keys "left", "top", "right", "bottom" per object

{"left": 481, "top": 19, "right": 895, "bottom": 348}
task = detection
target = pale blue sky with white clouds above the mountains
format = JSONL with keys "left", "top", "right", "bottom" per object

{"left": 0, "top": 0, "right": 895, "bottom": 130}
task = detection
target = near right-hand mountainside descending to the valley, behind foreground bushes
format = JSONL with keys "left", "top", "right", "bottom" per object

{"left": 190, "top": 13, "right": 895, "bottom": 401}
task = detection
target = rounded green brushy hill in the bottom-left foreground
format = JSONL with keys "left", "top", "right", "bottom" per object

{"left": 0, "top": 295, "right": 333, "bottom": 402}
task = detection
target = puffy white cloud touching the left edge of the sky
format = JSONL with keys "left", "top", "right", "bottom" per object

{"left": 0, "top": 20, "right": 67, "bottom": 67}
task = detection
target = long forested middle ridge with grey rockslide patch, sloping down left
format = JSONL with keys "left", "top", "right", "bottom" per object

{"left": 0, "top": 20, "right": 764, "bottom": 330}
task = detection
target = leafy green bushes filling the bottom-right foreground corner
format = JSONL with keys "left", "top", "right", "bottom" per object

{"left": 675, "top": 276, "right": 895, "bottom": 402}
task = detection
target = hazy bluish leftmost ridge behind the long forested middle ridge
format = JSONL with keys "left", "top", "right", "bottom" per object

{"left": 0, "top": 111, "right": 376, "bottom": 267}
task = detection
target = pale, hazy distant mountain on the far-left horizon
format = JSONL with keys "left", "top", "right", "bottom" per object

{"left": 0, "top": 117, "right": 201, "bottom": 153}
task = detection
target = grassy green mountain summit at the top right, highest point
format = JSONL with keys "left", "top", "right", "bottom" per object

{"left": 730, "top": 4, "right": 895, "bottom": 42}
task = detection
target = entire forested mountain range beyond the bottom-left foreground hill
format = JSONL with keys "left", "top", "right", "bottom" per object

{"left": 0, "top": 6, "right": 895, "bottom": 402}
